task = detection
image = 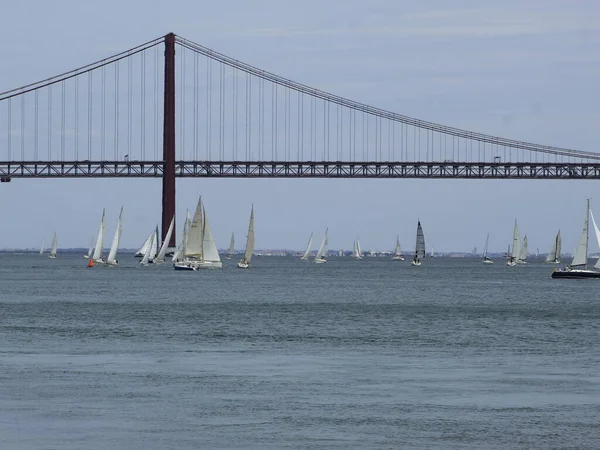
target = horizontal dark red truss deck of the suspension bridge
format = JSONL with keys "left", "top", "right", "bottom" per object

{"left": 0, "top": 161, "right": 600, "bottom": 181}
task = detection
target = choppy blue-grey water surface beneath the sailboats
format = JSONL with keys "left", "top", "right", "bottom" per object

{"left": 0, "top": 254, "right": 600, "bottom": 449}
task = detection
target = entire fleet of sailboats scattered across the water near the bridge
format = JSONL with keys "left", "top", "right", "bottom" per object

{"left": 32, "top": 197, "right": 600, "bottom": 278}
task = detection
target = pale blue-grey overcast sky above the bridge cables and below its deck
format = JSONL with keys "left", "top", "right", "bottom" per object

{"left": 0, "top": 0, "right": 600, "bottom": 252}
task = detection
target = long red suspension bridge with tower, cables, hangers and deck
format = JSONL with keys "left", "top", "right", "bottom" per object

{"left": 0, "top": 33, "right": 600, "bottom": 247}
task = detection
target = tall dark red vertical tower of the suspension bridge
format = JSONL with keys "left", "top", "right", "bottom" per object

{"left": 162, "top": 33, "right": 176, "bottom": 247}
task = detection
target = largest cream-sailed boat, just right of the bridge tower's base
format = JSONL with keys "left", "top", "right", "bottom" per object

{"left": 174, "top": 197, "right": 223, "bottom": 270}
